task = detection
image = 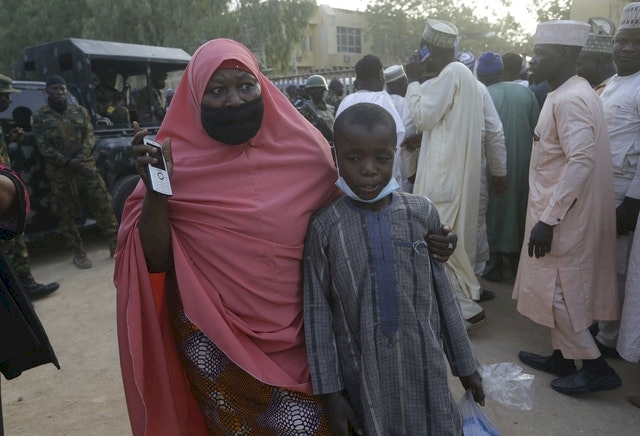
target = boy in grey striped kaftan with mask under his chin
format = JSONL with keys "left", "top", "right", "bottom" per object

{"left": 304, "top": 103, "right": 484, "bottom": 435}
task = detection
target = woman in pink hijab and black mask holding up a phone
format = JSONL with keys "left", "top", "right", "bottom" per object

{"left": 114, "top": 39, "right": 339, "bottom": 436}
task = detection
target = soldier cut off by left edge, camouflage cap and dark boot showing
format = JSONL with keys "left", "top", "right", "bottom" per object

{"left": 0, "top": 74, "right": 60, "bottom": 300}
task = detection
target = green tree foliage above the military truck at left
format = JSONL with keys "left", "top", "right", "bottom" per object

{"left": 0, "top": 0, "right": 315, "bottom": 75}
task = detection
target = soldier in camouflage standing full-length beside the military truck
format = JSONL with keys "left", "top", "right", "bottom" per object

{"left": 33, "top": 75, "right": 118, "bottom": 269}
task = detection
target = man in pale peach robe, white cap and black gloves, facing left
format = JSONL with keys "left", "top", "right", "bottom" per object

{"left": 513, "top": 20, "right": 622, "bottom": 396}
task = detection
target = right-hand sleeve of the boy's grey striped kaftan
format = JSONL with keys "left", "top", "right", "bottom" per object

{"left": 429, "top": 203, "right": 478, "bottom": 377}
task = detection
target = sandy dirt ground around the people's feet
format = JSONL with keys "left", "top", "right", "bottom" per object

{"left": 2, "top": 233, "right": 640, "bottom": 436}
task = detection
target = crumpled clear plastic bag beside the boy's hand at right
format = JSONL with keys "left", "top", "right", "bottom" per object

{"left": 478, "top": 362, "right": 534, "bottom": 410}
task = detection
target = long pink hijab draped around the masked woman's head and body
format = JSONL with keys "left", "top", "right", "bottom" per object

{"left": 114, "top": 39, "right": 339, "bottom": 435}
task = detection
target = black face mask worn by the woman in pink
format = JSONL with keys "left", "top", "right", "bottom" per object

{"left": 200, "top": 96, "right": 264, "bottom": 145}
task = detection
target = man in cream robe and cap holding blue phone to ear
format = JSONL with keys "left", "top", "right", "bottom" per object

{"left": 405, "top": 19, "right": 485, "bottom": 328}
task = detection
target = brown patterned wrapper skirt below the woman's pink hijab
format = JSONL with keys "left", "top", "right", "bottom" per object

{"left": 167, "top": 287, "right": 331, "bottom": 436}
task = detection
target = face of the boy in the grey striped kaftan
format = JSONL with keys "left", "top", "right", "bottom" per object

{"left": 334, "top": 125, "right": 396, "bottom": 204}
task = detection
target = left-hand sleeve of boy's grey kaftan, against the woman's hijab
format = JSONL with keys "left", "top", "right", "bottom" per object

{"left": 303, "top": 219, "right": 343, "bottom": 395}
